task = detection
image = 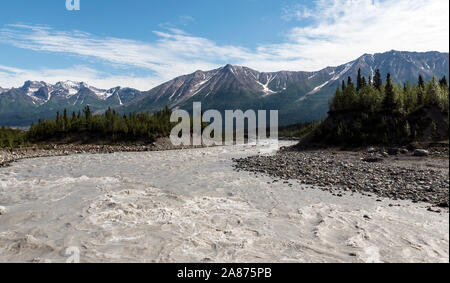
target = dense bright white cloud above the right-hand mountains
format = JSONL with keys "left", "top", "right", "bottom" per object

{"left": 244, "top": 0, "right": 449, "bottom": 71}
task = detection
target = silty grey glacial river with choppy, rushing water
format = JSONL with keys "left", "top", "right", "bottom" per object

{"left": 0, "top": 143, "right": 449, "bottom": 262}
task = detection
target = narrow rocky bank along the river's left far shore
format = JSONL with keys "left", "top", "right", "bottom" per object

{"left": 0, "top": 138, "right": 200, "bottom": 168}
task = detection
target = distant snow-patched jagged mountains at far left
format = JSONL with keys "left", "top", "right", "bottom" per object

{"left": 0, "top": 81, "right": 141, "bottom": 126}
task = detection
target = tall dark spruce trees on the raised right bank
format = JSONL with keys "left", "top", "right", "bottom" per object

{"left": 313, "top": 70, "right": 449, "bottom": 146}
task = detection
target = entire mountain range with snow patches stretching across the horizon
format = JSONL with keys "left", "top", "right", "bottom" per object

{"left": 0, "top": 51, "right": 449, "bottom": 126}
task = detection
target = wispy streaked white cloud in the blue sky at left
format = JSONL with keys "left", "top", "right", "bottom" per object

{"left": 0, "top": 25, "right": 247, "bottom": 86}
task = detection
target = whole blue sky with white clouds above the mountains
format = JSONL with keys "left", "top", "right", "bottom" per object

{"left": 0, "top": 0, "right": 449, "bottom": 90}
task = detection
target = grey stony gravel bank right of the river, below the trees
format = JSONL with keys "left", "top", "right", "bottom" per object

{"left": 234, "top": 148, "right": 449, "bottom": 212}
